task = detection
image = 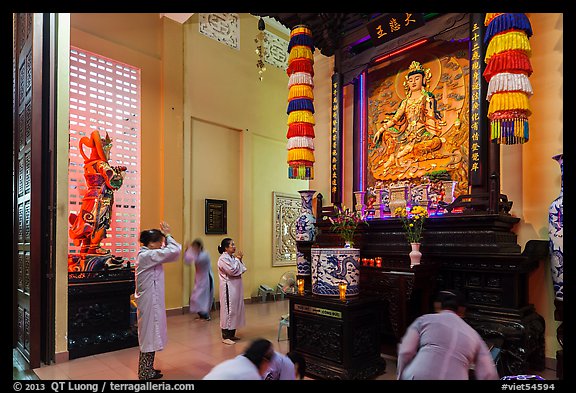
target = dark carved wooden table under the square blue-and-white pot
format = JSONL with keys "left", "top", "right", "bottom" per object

{"left": 287, "top": 292, "right": 386, "bottom": 380}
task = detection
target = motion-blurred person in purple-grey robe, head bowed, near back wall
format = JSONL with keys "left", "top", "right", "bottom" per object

{"left": 184, "top": 239, "right": 214, "bottom": 321}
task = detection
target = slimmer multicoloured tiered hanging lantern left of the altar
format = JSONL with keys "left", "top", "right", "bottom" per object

{"left": 286, "top": 25, "right": 315, "bottom": 180}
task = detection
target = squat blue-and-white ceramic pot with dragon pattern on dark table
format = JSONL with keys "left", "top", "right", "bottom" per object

{"left": 312, "top": 248, "right": 360, "bottom": 296}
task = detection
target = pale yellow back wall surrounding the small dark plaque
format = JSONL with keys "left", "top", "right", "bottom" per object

{"left": 184, "top": 14, "right": 312, "bottom": 304}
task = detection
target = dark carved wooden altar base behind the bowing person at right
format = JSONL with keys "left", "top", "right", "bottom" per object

{"left": 312, "top": 213, "right": 549, "bottom": 376}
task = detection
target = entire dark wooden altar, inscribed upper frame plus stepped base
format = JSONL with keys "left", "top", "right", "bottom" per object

{"left": 313, "top": 14, "right": 548, "bottom": 375}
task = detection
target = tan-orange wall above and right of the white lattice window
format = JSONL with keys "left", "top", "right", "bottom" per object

{"left": 70, "top": 13, "right": 183, "bottom": 316}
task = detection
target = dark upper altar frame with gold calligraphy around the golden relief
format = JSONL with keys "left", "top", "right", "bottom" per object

{"left": 331, "top": 13, "right": 511, "bottom": 214}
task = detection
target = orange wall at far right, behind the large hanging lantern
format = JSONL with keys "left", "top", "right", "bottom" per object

{"left": 501, "top": 13, "right": 564, "bottom": 358}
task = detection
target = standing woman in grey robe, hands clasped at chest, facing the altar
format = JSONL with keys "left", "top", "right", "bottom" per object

{"left": 218, "top": 237, "right": 246, "bottom": 345}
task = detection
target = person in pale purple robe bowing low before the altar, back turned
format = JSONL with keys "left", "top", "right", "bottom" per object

{"left": 396, "top": 290, "right": 499, "bottom": 380}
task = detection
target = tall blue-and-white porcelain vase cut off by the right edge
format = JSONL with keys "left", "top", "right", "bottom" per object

{"left": 548, "top": 154, "right": 564, "bottom": 300}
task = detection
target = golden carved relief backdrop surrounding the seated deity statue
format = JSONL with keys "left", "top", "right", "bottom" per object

{"left": 366, "top": 41, "right": 471, "bottom": 197}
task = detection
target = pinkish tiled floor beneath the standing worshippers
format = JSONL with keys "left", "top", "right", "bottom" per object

{"left": 23, "top": 300, "right": 556, "bottom": 380}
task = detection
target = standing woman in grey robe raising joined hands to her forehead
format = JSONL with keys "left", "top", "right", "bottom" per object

{"left": 134, "top": 221, "right": 182, "bottom": 380}
